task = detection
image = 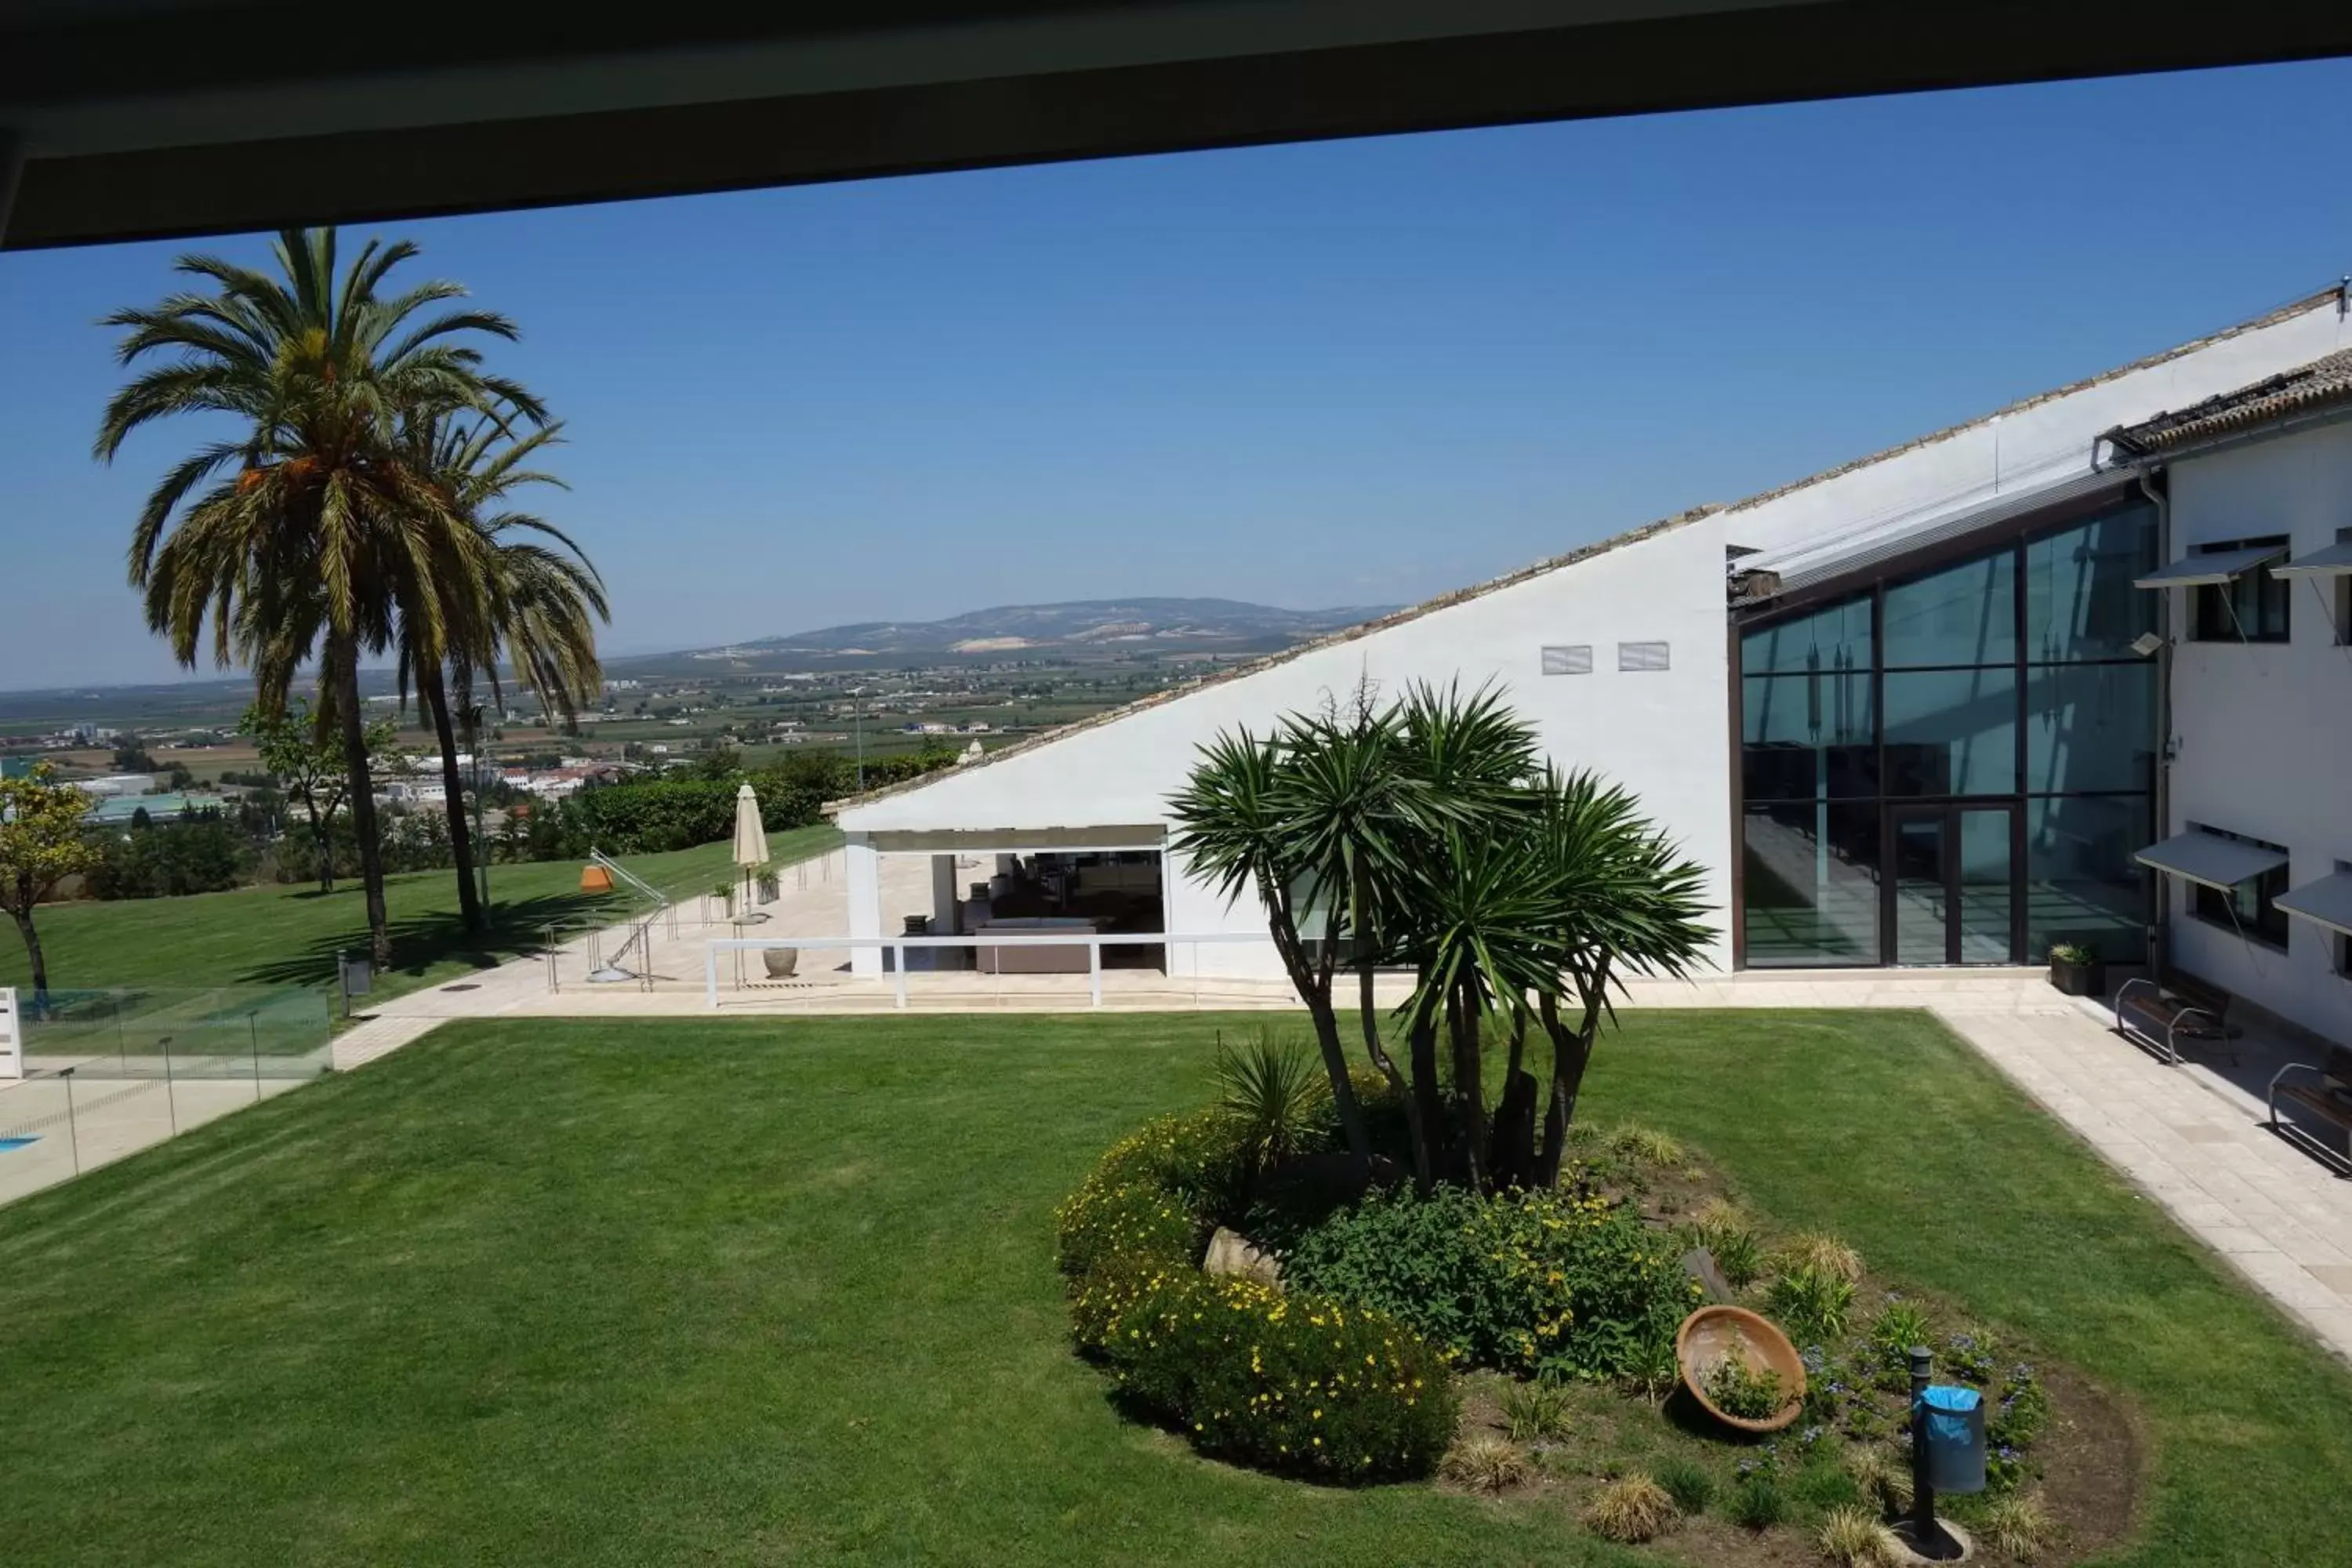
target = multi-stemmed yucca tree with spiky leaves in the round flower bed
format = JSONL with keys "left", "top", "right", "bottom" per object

{"left": 1171, "top": 687, "right": 1708, "bottom": 1187}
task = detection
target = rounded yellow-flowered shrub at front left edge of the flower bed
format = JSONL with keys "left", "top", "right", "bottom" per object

{"left": 1101, "top": 1269, "right": 1456, "bottom": 1481}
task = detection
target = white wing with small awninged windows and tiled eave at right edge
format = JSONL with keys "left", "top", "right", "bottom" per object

{"left": 2112, "top": 353, "right": 2352, "bottom": 1044}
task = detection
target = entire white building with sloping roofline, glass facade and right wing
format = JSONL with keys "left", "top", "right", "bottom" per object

{"left": 837, "top": 289, "right": 2352, "bottom": 1039}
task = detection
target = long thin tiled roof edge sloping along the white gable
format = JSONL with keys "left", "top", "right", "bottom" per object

{"left": 826, "top": 287, "right": 2352, "bottom": 813}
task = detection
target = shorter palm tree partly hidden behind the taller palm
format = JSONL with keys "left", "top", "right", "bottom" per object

{"left": 400, "top": 414, "right": 597, "bottom": 931}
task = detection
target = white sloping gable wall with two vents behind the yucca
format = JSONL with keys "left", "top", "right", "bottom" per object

{"left": 840, "top": 517, "right": 1731, "bottom": 975}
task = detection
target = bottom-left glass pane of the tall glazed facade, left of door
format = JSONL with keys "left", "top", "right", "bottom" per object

{"left": 1740, "top": 801, "right": 1879, "bottom": 968}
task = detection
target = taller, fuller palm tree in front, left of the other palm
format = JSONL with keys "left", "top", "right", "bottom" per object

{"left": 94, "top": 228, "right": 546, "bottom": 964}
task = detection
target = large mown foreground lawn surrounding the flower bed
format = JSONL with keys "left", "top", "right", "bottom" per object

{"left": 0, "top": 1013, "right": 2352, "bottom": 1568}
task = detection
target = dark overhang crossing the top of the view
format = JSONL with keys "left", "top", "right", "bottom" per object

{"left": 0, "top": 0, "right": 2352, "bottom": 247}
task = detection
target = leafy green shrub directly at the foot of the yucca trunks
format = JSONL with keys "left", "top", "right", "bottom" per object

{"left": 1282, "top": 1187, "right": 1698, "bottom": 1377}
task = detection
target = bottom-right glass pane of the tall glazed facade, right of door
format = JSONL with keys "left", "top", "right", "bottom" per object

{"left": 2025, "top": 794, "right": 2152, "bottom": 964}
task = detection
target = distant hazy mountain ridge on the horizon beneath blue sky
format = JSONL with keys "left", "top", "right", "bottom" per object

{"left": 734, "top": 600, "right": 1390, "bottom": 656}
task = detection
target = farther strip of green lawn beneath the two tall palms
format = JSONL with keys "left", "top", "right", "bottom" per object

{"left": 0, "top": 825, "right": 842, "bottom": 999}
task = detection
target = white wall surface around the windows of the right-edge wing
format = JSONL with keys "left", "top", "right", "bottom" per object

{"left": 2164, "top": 426, "right": 2352, "bottom": 1041}
